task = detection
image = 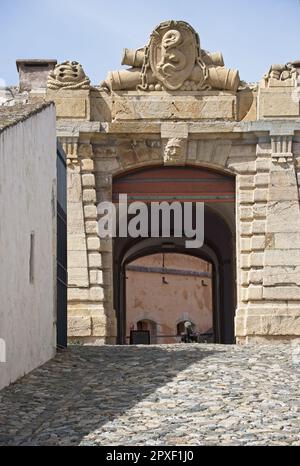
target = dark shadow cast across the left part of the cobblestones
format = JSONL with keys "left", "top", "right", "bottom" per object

{"left": 0, "top": 345, "right": 220, "bottom": 445}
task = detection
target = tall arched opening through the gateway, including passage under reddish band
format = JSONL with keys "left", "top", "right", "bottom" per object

{"left": 113, "top": 167, "right": 236, "bottom": 344}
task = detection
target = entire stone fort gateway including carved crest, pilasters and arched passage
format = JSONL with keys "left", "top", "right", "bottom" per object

{"left": 14, "top": 21, "right": 300, "bottom": 344}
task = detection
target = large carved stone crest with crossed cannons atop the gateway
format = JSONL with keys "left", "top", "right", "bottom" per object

{"left": 102, "top": 21, "right": 240, "bottom": 92}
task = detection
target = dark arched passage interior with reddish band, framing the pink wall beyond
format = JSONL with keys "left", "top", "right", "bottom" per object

{"left": 113, "top": 167, "right": 236, "bottom": 343}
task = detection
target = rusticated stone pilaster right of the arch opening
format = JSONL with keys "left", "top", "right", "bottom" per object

{"left": 236, "top": 135, "right": 300, "bottom": 342}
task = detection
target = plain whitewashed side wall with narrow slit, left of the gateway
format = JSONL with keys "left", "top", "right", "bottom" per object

{"left": 0, "top": 105, "right": 56, "bottom": 389}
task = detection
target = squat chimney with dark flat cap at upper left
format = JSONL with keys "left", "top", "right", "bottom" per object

{"left": 16, "top": 59, "right": 57, "bottom": 92}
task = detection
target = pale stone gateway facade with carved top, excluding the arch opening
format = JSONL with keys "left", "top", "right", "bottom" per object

{"left": 5, "top": 21, "right": 300, "bottom": 344}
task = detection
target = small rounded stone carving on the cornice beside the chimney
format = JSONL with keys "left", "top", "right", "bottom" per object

{"left": 47, "top": 61, "right": 90, "bottom": 90}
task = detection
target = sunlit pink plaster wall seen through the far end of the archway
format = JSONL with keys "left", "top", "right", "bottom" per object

{"left": 126, "top": 253, "right": 213, "bottom": 343}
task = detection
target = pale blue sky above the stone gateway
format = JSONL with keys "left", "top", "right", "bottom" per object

{"left": 0, "top": 0, "right": 300, "bottom": 85}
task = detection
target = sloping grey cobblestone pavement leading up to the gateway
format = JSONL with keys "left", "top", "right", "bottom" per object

{"left": 0, "top": 344, "right": 300, "bottom": 445}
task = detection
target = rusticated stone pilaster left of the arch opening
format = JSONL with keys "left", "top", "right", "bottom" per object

{"left": 65, "top": 138, "right": 112, "bottom": 344}
